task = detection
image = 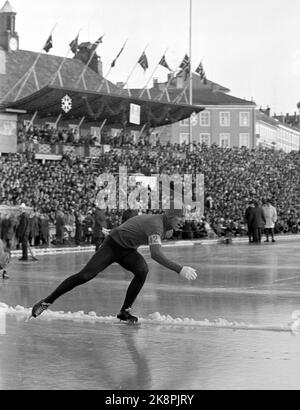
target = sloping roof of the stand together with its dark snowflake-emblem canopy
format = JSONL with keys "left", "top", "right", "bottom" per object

{"left": 0, "top": 50, "right": 204, "bottom": 127}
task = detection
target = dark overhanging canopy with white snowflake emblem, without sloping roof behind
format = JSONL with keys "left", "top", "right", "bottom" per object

{"left": 3, "top": 85, "right": 204, "bottom": 127}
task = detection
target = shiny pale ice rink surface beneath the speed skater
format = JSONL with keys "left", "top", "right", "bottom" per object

{"left": 0, "top": 238, "right": 300, "bottom": 390}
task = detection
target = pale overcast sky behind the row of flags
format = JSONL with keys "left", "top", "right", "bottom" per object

{"left": 5, "top": 0, "right": 300, "bottom": 114}
